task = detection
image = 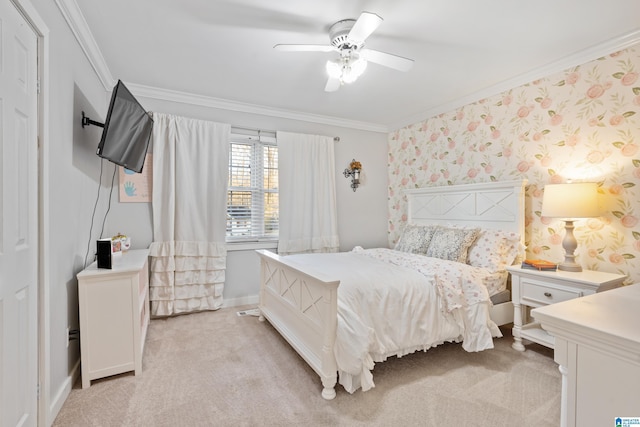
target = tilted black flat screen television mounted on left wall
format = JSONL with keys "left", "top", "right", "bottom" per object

{"left": 97, "top": 80, "right": 153, "bottom": 173}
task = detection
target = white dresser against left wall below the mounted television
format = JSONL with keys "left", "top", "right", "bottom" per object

{"left": 77, "top": 249, "right": 149, "bottom": 388}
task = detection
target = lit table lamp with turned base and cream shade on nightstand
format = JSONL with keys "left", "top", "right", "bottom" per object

{"left": 542, "top": 182, "right": 600, "bottom": 271}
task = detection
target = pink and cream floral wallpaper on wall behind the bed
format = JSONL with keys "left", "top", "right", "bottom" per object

{"left": 388, "top": 45, "right": 640, "bottom": 283}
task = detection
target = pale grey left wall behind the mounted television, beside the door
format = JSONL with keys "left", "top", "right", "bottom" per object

{"left": 28, "top": 0, "right": 113, "bottom": 424}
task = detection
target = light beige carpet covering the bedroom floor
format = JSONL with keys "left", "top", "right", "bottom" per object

{"left": 54, "top": 307, "right": 561, "bottom": 427}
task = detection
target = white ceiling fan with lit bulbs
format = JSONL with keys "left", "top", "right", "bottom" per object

{"left": 273, "top": 12, "right": 413, "bottom": 92}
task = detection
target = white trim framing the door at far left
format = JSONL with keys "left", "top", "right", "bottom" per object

{"left": 11, "top": 0, "right": 49, "bottom": 426}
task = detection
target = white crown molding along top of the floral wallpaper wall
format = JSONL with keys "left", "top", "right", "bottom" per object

{"left": 389, "top": 28, "right": 640, "bottom": 132}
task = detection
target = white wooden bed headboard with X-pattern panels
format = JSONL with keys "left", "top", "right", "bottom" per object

{"left": 405, "top": 180, "right": 527, "bottom": 237}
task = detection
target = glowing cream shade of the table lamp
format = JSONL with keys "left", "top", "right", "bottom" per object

{"left": 542, "top": 182, "right": 600, "bottom": 218}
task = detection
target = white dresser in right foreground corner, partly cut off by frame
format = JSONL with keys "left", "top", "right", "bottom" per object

{"left": 531, "top": 284, "right": 640, "bottom": 427}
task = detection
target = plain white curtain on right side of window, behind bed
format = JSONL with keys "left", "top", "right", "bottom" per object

{"left": 276, "top": 132, "right": 340, "bottom": 255}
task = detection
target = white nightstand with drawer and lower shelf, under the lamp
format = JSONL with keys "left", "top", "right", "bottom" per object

{"left": 507, "top": 266, "right": 627, "bottom": 351}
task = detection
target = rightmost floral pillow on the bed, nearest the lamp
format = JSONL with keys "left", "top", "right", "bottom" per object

{"left": 467, "top": 229, "right": 520, "bottom": 272}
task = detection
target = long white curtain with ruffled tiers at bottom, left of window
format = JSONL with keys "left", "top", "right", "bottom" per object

{"left": 150, "top": 113, "right": 231, "bottom": 316}
